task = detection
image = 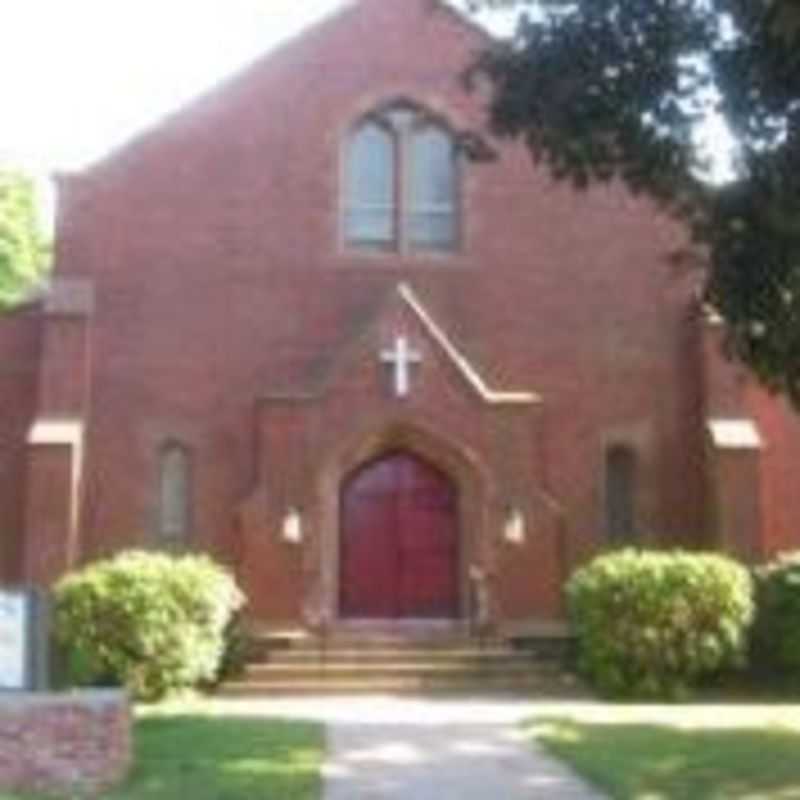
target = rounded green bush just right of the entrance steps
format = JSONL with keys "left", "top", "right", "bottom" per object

{"left": 567, "top": 550, "right": 753, "bottom": 697}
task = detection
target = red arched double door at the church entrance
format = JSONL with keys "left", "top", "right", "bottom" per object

{"left": 340, "top": 452, "right": 459, "bottom": 619}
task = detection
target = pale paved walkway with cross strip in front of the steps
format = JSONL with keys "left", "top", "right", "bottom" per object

{"left": 209, "top": 697, "right": 800, "bottom": 800}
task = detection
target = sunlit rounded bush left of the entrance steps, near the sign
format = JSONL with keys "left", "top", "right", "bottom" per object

{"left": 55, "top": 552, "right": 243, "bottom": 700}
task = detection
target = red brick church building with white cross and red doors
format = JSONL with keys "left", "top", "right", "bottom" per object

{"left": 0, "top": 0, "right": 800, "bottom": 631}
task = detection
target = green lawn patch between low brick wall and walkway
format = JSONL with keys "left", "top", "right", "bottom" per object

{"left": 0, "top": 706, "right": 324, "bottom": 800}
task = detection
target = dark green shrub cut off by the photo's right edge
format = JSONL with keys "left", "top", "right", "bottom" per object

{"left": 753, "top": 552, "right": 800, "bottom": 678}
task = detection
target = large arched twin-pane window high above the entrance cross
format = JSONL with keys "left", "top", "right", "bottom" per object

{"left": 344, "top": 104, "right": 458, "bottom": 251}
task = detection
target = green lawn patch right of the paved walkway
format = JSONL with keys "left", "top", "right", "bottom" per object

{"left": 527, "top": 719, "right": 800, "bottom": 800}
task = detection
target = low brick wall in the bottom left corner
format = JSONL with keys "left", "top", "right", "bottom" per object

{"left": 0, "top": 691, "right": 131, "bottom": 797}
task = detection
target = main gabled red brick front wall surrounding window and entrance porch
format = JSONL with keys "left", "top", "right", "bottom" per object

{"left": 45, "top": 0, "right": 704, "bottom": 615}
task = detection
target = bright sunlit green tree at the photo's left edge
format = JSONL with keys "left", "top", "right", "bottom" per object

{"left": 0, "top": 170, "right": 49, "bottom": 308}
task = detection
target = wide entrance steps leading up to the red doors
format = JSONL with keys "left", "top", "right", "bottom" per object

{"left": 219, "top": 632, "right": 578, "bottom": 697}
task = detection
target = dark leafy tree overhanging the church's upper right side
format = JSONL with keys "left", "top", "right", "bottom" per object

{"left": 465, "top": 0, "right": 800, "bottom": 400}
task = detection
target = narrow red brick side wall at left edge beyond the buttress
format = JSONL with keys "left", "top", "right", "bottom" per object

{"left": 0, "top": 307, "right": 41, "bottom": 581}
